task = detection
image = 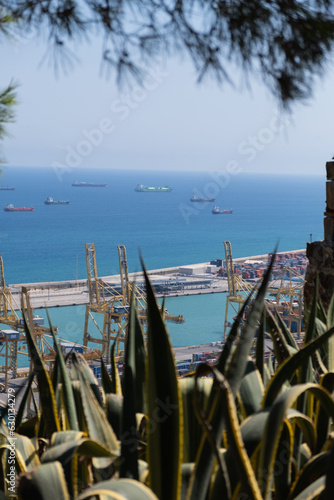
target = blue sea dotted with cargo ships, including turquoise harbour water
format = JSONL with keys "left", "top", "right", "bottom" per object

{"left": 0, "top": 167, "right": 326, "bottom": 358}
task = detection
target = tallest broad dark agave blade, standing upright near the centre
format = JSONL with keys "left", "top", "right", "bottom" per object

{"left": 142, "top": 261, "right": 183, "bottom": 500}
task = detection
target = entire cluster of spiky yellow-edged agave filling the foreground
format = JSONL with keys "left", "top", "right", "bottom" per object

{"left": 0, "top": 256, "right": 334, "bottom": 500}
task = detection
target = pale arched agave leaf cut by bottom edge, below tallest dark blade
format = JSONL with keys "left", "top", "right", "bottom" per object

{"left": 77, "top": 479, "right": 160, "bottom": 500}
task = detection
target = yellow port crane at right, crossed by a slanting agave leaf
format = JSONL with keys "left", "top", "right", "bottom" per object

{"left": 224, "top": 241, "right": 305, "bottom": 339}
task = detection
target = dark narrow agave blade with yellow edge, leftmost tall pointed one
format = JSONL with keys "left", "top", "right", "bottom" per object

{"left": 20, "top": 302, "right": 60, "bottom": 436}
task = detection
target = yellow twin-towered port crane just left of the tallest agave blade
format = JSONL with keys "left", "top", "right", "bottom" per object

{"left": 83, "top": 243, "right": 184, "bottom": 360}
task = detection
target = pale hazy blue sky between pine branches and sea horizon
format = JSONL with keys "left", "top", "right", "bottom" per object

{"left": 0, "top": 31, "right": 334, "bottom": 175}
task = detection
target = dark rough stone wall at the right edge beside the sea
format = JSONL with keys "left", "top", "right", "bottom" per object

{"left": 304, "top": 161, "right": 334, "bottom": 310}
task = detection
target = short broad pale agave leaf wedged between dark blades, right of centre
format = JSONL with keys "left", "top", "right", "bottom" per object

{"left": 238, "top": 359, "right": 264, "bottom": 418}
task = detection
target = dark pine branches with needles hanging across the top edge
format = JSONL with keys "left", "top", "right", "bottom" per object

{"left": 0, "top": 0, "right": 334, "bottom": 106}
